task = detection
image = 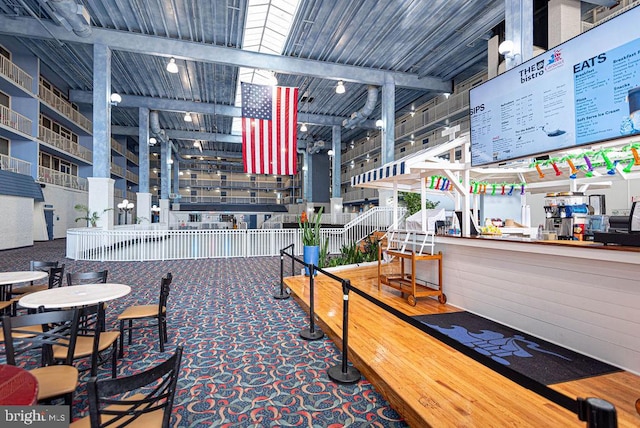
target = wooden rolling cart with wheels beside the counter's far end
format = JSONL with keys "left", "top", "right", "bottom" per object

{"left": 378, "top": 231, "right": 447, "bottom": 306}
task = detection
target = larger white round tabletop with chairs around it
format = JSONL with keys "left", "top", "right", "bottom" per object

{"left": 18, "top": 283, "right": 131, "bottom": 309}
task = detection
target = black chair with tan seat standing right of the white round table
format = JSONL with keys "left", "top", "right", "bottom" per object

{"left": 118, "top": 272, "right": 173, "bottom": 358}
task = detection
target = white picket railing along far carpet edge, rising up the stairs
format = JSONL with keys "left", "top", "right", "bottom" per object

{"left": 67, "top": 207, "right": 400, "bottom": 261}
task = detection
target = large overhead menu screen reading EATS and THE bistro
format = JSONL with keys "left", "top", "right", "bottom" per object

{"left": 469, "top": 7, "right": 640, "bottom": 166}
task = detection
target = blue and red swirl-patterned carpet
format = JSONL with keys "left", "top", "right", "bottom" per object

{"left": 0, "top": 240, "right": 407, "bottom": 428}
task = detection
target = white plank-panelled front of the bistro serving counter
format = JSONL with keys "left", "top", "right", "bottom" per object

{"left": 428, "top": 236, "right": 640, "bottom": 376}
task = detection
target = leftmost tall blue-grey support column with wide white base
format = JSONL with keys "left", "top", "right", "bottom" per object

{"left": 88, "top": 44, "right": 115, "bottom": 229}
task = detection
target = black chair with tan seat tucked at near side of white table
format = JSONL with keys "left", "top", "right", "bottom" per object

{"left": 53, "top": 302, "right": 120, "bottom": 378}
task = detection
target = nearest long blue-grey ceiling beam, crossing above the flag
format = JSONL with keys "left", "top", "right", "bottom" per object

{"left": 0, "top": 15, "right": 453, "bottom": 93}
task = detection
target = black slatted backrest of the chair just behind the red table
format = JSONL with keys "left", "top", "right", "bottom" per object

{"left": 2, "top": 309, "right": 79, "bottom": 366}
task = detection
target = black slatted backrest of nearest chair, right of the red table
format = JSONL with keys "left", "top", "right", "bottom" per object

{"left": 87, "top": 346, "right": 182, "bottom": 427}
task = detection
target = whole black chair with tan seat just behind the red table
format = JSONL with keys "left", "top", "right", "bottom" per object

{"left": 2, "top": 309, "right": 79, "bottom": 406}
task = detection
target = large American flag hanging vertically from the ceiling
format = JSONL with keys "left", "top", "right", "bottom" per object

{"left": 241, "top": 83, "right": 298, "bottom": 175}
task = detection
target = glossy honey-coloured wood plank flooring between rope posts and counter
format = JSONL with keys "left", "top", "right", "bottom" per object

{"left": 285, "top": 266, "right": 640, "bottom": 427}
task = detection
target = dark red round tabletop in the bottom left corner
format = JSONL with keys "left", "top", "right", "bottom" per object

{"left": 0, "top": 364, "right": 38, "bottom": 406}
